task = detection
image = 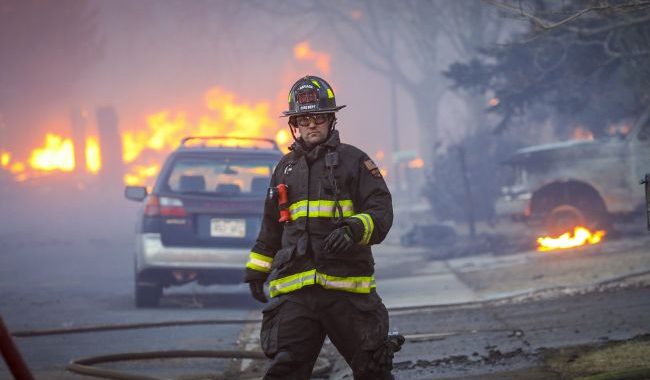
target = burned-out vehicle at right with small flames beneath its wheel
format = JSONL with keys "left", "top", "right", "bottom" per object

{"left": 495, "top": 111, "right": 650, "bottom": 235}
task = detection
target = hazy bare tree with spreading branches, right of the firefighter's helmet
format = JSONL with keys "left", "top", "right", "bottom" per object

{"left": 260, "top": 0, "right": 506, "bottom": 162}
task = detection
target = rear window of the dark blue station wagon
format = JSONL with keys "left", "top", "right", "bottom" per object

{"left": 166, "top": 158, "right": 275, "bottom": 196}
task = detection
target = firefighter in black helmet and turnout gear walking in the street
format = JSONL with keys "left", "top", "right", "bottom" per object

{"left": 246, "top": 76, "right": 403, "bottom": 380}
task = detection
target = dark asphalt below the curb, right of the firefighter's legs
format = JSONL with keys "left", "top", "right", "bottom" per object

{"left": 380, "top": 286, "right": 650, "bottom": 380}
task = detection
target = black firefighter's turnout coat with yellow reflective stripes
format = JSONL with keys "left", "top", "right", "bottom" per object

{"left": 246, "top": 130, "right": 393, "bottom": 297}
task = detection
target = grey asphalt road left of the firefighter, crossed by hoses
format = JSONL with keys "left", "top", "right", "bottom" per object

{"left": 0, "top": 199, "right": 259, "bottom": 379}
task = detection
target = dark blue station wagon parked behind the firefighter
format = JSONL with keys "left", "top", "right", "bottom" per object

{"left": 125, "top": 137, "right": 282, "bottom": 307}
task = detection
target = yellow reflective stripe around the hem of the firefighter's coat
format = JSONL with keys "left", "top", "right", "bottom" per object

{"left": 269, "top": 269, "right": 377, "bottom": 297}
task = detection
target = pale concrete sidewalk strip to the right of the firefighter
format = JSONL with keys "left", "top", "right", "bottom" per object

{"left": 373, "top": 237, "right": 650, "bottom": 308}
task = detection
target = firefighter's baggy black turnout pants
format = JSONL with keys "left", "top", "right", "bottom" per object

{"left": 260, "top": 285, "right": 393, "bottom": 380}
